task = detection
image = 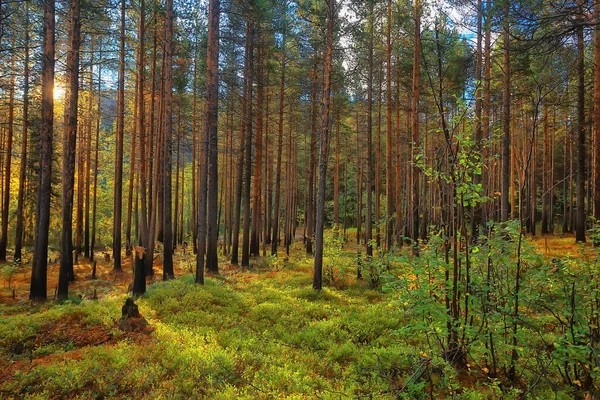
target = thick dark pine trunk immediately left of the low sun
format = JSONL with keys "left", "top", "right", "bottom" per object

{"left": 29, "top": 0, "right": 55, "bottom": 300}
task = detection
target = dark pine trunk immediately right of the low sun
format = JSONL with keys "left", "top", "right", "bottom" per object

{"left": 57, "top": 0, "right": 83, "bottom": 300}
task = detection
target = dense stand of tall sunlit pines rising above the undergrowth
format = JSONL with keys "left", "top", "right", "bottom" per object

{"left": 0, "top": 0, "right": 600, "bottom": 300}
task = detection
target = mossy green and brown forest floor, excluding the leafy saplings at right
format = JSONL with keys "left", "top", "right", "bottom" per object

{"left": 0, "top": 235, "right": 594, "bottom": 399}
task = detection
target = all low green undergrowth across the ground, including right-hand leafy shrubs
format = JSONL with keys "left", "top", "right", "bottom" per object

{"left": 0, "top": 230, "right": 600, "bottom": 399}
